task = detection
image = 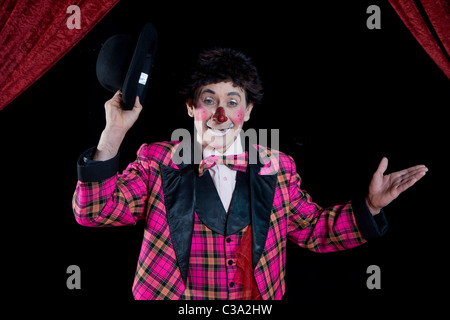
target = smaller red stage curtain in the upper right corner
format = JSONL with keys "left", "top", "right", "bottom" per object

{"left": 389, "top": 0, "right": 450, "bottom": 79}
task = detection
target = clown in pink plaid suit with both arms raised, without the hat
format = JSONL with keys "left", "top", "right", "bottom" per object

{"left": 73, "top": 48, "right": 427, "bottom": 300}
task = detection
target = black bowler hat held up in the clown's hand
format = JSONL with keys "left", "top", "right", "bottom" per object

{"left": 96, "top": 23, "right": 158, "bottom": 110}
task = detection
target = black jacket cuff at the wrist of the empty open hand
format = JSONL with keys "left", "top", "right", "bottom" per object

{"left": 352, "top": 197, "right": 388, "bottom": 240}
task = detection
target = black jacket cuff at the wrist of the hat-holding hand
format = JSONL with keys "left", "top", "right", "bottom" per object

{"left": 77, "top": 147, "right": 119, "bottom": 182}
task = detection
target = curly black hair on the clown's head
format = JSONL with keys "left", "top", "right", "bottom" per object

{"left": 180, "top": 47, "right": 263, "bottom": 105}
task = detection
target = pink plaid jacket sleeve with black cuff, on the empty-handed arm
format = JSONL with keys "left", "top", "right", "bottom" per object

{"left": 288, "top": 157, "right": 387, "bottom": 252}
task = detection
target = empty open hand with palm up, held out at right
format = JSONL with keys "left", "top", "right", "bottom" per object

{"left": 366, "top": 158, "right": 428, "bottom": 215}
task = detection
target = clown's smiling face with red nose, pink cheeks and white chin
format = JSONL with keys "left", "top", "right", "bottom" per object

{"left": 186, "top": 82, "right": 253, "bottom": 152}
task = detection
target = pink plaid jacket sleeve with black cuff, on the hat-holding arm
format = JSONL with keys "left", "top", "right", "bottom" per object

{"left": 72, "top": 145, "right": 150, "bottom": 227}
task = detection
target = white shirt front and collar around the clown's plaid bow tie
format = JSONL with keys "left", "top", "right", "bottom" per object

{"left": 203, "top": 135, "right": 244, "bottom": 212}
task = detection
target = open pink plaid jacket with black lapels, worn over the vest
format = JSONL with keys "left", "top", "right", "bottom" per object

{"left": 73, "top": 142, "right": 385, "bottom": 299}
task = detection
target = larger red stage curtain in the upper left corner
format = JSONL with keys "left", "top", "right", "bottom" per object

{"left": 0, "top": 0, "right": 119, "bottom": 110}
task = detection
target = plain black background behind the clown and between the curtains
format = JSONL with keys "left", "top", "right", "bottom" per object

{"left": 0, "top": 0, "right": 449, "bottom": 317}
